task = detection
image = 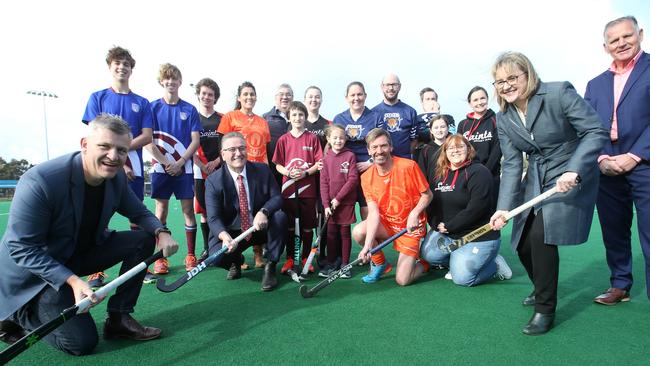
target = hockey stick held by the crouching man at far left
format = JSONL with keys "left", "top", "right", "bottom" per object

{"left": 0, "top": 250, "right": 163, "bottom": 365}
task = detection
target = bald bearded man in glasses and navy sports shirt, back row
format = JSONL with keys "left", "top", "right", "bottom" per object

{"left": 372, "top": 74, "right": 418, "bottom": 159}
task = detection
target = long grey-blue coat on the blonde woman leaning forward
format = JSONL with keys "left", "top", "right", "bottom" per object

{"left": 497, "top": 82, "right": 607, "bottom": 248}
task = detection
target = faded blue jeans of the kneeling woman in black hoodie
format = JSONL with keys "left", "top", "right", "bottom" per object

{"left": 420, "top": 230, "right": 501, "bottom": 286}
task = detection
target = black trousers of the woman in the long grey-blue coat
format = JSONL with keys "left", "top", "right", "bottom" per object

{"left": 517, "top": 210, "right": 560, "bottom": 314}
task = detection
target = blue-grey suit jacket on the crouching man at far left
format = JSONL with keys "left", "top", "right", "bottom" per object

{"left": 0, "top": 152, "right": 162, "bottom": 320}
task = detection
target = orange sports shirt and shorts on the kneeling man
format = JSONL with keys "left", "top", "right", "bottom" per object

{"left": 361, "top": 156, "right": 429, "bottom": 258}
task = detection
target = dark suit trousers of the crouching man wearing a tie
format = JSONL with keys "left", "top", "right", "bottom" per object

{"left": 210, "top": 210, "right": 288, "bottom": 269}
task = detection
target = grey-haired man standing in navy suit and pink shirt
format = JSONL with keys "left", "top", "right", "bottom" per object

{"left": 585, "top": 16, "right": 650, "bottom": 305}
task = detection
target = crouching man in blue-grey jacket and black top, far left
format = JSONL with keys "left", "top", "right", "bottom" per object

{"left": 0, "top": 114, "right": 178, "bottom": 355}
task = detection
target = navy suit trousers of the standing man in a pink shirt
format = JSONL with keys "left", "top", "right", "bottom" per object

{"left": 596, "top": 164, "right": 650, "bottom": 298}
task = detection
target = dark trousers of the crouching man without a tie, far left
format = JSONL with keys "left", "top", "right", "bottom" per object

{"left": 9, "top": 231, "right": 155, "bottom": 355}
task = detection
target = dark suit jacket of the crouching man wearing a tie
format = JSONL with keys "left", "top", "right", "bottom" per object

{"left": 205, "top": 161, "right": 282, "bottom": 246}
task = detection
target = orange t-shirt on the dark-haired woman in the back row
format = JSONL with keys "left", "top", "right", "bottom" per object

{"left": 217, "top": 110, "right": 271, "bottom": 164}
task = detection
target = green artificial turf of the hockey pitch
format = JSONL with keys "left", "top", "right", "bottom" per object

{"left": 0, "top": 200, "right": 650, "bottom": 366}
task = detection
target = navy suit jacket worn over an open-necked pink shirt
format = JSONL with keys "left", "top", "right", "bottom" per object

{"left": 585, "top": 52, "right": 650, "bottom": 164}
